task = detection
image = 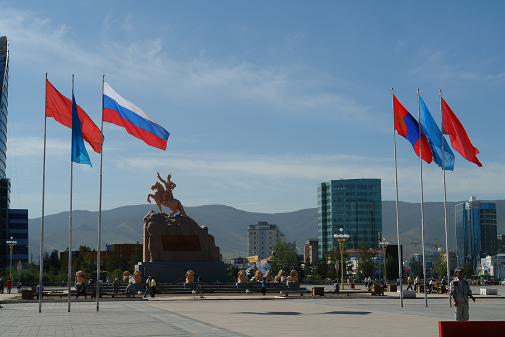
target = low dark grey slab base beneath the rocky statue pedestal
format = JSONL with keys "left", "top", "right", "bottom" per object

{"left": 135, "top": 261, "right": 226, "bottom": 283}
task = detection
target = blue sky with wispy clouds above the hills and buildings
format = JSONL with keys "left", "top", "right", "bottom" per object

{"left": 0, "top": 0, "right": 505, "bottom": 217}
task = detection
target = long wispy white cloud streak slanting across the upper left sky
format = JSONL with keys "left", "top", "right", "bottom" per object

{"left": 0, "top": 8, "right": 373, "bottom": 122}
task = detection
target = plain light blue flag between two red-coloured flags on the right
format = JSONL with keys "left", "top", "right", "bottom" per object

{"left": 419, "top": 96, "right": 454, "bottom": 171}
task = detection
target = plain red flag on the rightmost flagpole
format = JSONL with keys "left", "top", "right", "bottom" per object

{"left": 442, "top": 98, "right": 482, "bottom": 167}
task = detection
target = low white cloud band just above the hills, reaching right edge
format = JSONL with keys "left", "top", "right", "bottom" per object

{"left": 120, "top": 154, "right": 505, "bottom": 201}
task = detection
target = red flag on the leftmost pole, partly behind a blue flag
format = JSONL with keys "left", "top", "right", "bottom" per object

{"left": 46, "top": 81, "right": 103, "bottom": 153}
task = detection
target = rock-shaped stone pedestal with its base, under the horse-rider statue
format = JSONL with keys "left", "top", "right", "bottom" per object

{"left": 135, "top": 212, "right": 226, "bottom": 283}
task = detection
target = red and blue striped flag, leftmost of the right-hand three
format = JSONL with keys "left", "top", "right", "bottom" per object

{"left": 393, "top": 95, "right": 433, "bottom": 164}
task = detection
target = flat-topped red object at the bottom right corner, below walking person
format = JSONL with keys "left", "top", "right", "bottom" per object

{"left": 438, "top": 321, "right": 505, "bottom": 337}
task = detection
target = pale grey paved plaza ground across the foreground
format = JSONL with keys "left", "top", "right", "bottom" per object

{"left": 0, "top": 294, "right": 505, "bottom": 337}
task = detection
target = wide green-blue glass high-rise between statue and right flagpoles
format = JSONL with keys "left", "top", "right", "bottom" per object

{"left": 318, "top": 179, "right": 382, "bottom": 258}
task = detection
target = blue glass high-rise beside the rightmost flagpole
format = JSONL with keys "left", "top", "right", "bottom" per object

{"left": 455, "top": 197, "right": 497, "bottom": 269}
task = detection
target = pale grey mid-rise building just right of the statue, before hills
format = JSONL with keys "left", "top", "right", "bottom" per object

{"left": 248, "top": 221, "right": 286, "bottom": 259}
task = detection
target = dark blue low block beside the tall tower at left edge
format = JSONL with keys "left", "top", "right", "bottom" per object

{"left": 8, "top": 209, "right": 28, "bottom": 266}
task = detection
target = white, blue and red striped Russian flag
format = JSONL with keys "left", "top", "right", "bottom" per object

{"left": 103, "top": 82, "right": 170, "bottom": 150}
